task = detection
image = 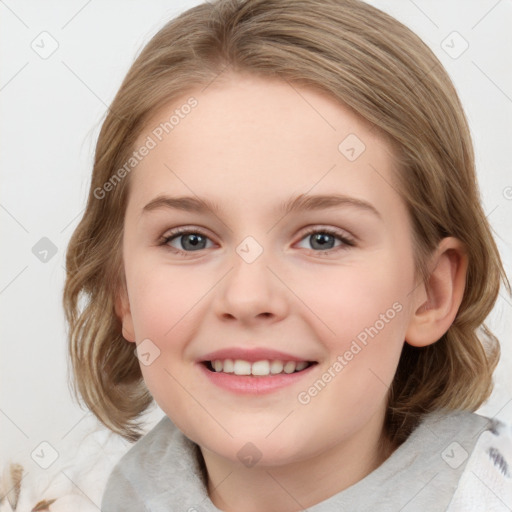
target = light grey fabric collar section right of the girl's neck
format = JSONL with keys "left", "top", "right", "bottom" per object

{"left": 298, "top": 410, "right": 510, "bottom": 512}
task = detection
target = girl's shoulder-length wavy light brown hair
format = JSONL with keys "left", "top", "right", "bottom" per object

{"left": 63, "top": 0, "right": 510, "bottom": 444}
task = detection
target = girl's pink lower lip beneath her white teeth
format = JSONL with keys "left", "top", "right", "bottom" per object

{"left": 199, "top": 363, "right": 316, "bottom": 395}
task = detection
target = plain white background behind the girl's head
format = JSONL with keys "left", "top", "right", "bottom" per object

{"left": 0, "top": 0, "right": 512, "bottom": 474}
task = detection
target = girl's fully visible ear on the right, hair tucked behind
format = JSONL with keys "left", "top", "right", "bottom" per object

{"left": 405, "top": 237, "right": 468, "bottom": 347}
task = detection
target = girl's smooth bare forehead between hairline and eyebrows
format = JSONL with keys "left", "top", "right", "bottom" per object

{"left": 131, "top": 74, "right": 399, "bottom": 218}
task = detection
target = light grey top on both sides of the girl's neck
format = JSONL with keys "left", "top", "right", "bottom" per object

{"left": 101, "top": 411, "right": 500, "bottom": 512}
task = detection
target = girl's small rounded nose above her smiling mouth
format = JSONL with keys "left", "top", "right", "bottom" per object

{"left": 214, "top": 246, "right": 289, "bottom": 325}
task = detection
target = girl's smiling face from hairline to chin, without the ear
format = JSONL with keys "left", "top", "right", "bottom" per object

{"left": 119, "top": 74, "right": 415, "bottom": 466}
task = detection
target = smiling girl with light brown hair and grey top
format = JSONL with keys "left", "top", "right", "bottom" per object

{"left": 64, "top": 0, "right": 512, "bottom": 512}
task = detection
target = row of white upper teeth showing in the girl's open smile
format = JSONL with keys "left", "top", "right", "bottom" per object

{"left": 202, "top": 359, "right": 317, "bottom": 377}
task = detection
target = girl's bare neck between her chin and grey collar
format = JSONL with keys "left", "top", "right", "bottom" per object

{"left": 201, "top": 408, "right": 396, "bottom": 512}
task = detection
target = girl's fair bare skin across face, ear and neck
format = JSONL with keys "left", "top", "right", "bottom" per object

{"left": 117, "top": 74, "right": 467, "bottom": 512}
